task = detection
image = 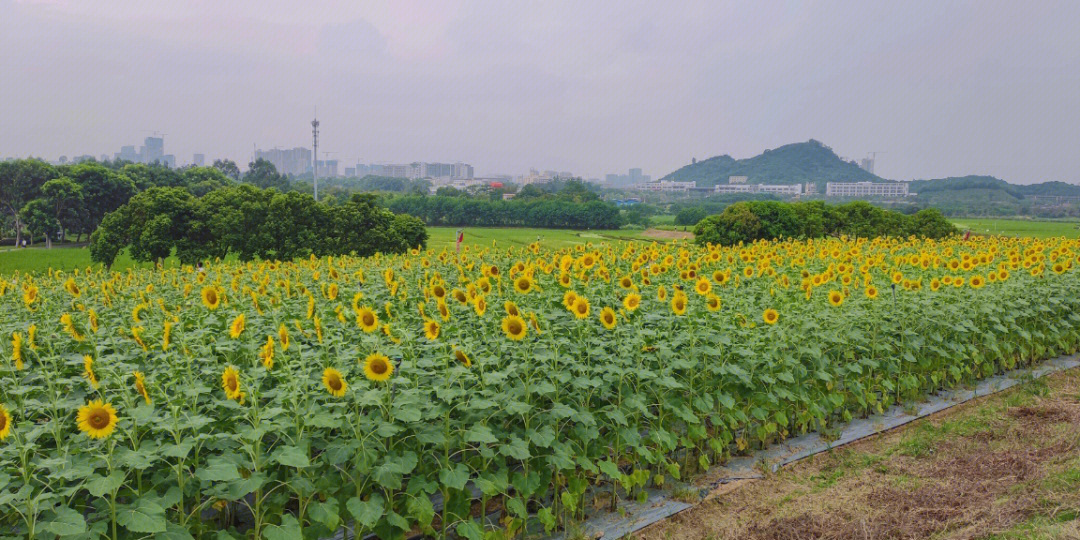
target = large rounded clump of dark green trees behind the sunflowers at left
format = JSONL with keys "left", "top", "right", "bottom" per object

{"left": 90, "top": 185, "right": 428, "bottom": 266}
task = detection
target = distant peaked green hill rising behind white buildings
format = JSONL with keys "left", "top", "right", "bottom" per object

{"left": 661, "top": 139, "right": 887, "bottom": 187}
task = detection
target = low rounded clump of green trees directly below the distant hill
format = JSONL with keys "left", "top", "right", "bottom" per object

{"left": 693, "top": 201, "right": 958, "bottom": 245}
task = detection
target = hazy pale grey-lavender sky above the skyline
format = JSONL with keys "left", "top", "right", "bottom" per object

{"left": 0, "top": 0, "right": 1080, "bottom": 183}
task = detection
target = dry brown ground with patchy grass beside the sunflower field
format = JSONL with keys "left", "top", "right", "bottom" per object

{"left": 634, "top": 369, "right": 1080, "bottom": 540}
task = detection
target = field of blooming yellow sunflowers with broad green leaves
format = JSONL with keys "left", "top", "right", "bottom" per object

{"left": 0, "top": 238, "right": 1080, "bottom": 540}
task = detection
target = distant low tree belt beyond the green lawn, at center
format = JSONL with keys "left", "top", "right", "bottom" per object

{"left": 384, "top": 195, "right": 623, "bottom": 229}
